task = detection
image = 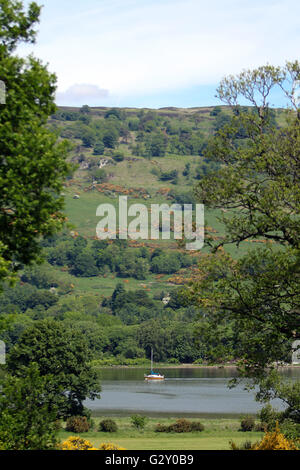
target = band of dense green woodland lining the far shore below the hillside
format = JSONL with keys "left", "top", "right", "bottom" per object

{"left": 0, "top": 258, "right": 213, "bottom": 367}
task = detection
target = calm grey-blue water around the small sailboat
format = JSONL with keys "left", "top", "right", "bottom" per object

{"left": 85, "top": 368, "right": 300, "bottom": 417}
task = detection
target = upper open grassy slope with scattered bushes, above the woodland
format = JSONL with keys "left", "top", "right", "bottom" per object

{"left": 49, "top": 106, "right": 276, "bottom": 280}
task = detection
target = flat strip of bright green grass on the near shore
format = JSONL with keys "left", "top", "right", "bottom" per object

{"left": 59, "top": 416, "right": 263, "bottom": 450}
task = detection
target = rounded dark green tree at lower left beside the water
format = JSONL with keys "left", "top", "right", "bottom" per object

{"left": 6, "top": 319, "right": 101, "bottom": 418}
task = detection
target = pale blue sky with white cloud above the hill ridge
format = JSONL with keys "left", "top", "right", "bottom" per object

{"left": 18, "top": 0, "right": 300, "bottom": 108}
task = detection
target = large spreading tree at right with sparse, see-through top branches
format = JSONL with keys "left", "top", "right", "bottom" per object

{"left": 189, "top": 62, "right": 300, "bottom": 377}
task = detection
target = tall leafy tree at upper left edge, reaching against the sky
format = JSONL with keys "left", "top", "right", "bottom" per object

{"left": 0, "top": 0, "right": 69, "bottom": 286}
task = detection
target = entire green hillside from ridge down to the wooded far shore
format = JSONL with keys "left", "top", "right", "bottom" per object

{"left": 0, "top": 106, "right": 282, "bottom": 365}
